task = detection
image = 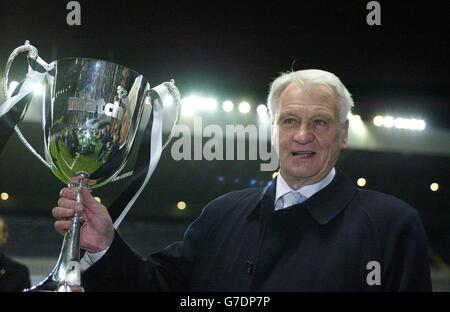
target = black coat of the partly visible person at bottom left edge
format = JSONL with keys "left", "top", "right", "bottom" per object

{"left": 0, "top": 253, "right": 30, "bottom": 292}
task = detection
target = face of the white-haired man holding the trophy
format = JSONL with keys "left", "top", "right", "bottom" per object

{"left": 274, "top": 82, "right": 348, "bottom": 189}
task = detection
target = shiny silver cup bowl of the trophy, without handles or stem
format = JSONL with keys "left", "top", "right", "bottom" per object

{"left": 44, "top": 58, "right": 149, "bottom": 187}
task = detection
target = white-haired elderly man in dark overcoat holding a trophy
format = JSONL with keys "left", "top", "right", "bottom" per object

{"left": 53, "top": 70, "right": 431, "bottom": 291}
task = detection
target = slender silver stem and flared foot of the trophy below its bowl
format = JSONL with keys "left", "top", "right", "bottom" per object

{"left": 27, "top": 172, "right": 88, "bottom": 292}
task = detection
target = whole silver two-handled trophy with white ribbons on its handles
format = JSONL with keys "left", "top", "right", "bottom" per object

{"left": 0, "top": 42, "right": 180, "bottom": 291}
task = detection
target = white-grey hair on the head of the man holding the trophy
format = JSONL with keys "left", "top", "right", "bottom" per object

{"left": 267, "top": 69, "right": 355, "bottom": 123}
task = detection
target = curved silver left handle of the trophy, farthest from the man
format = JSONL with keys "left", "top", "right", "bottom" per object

{"left": 3, "top": 40, "right": 53, "bottom": 168}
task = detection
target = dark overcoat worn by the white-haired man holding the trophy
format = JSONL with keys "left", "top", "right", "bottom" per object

{"left": 83, "top": 170, "right": 431, "bottom": 291}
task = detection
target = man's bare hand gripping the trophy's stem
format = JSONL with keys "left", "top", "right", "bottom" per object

{"left": 52, "top": 187, "right": 114, "bottom": 253}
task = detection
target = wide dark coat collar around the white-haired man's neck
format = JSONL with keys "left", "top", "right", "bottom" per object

{"left": 244, "top": 168, "right": 356, "bottom": 225}
